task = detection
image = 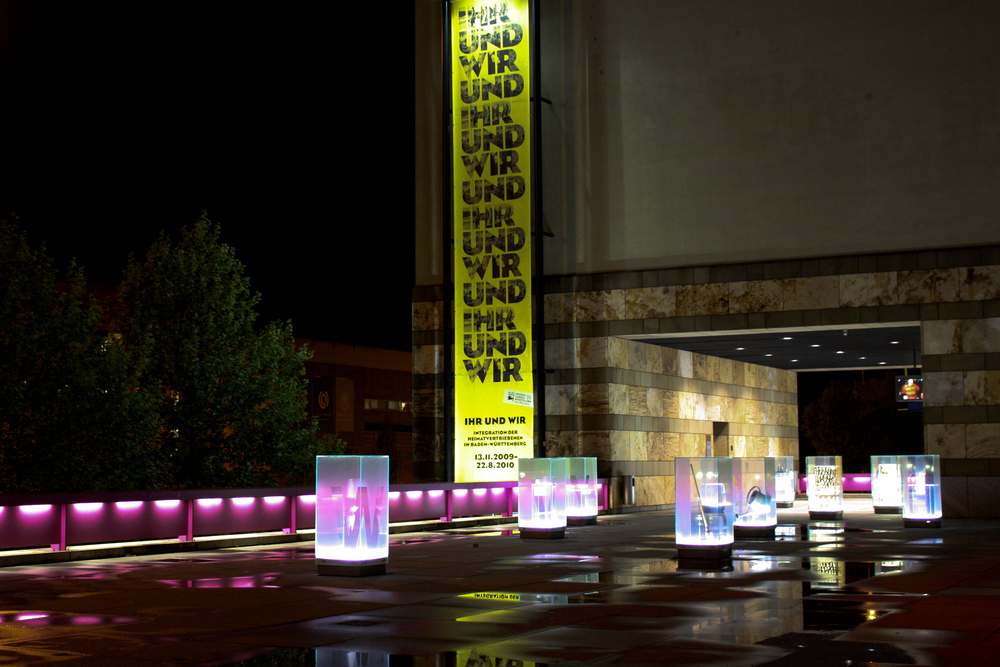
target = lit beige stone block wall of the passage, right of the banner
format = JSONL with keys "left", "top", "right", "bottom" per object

{"left": 545, "top": 336, "right": 798, "bottom": 506}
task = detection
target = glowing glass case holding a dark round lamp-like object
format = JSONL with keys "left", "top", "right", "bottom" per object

{"left": 733, "top": 456, "right": 778, "bottom": 539}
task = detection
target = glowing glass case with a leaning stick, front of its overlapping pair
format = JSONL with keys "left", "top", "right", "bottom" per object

{"left": 674, "top": 456, "right": 734, "bottom": 559}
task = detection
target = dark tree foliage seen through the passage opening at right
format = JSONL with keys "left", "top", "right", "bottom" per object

{"left": 802, "top": 376, "right": 923, "bottom": 472}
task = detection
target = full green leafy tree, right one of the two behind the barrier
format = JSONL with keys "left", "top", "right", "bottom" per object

{"left": 113, "top": 214, "right": 334, "bottom": 488}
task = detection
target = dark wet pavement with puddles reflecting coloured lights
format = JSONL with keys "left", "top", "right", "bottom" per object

{"left": 0, "top": 496, "right": 1000, "bottom": 667}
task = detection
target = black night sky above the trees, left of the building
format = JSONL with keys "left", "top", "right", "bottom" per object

{"left": 0, "top": 0, "right": 414, "bottom": 350}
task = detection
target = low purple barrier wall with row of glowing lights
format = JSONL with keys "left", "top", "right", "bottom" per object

{"left": 0, "top": 480, "right": 608, "bottom": 551}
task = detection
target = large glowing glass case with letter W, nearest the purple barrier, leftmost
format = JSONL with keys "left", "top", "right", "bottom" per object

{"left": 316, "top": 456, "right": 389, "bottom": 576}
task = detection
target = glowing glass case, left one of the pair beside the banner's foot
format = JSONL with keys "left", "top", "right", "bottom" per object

{"left": 517, "top": 458, "right": 566, "bottom": 539}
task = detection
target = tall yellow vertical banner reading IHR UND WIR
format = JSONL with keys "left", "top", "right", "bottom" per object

{"left": 450, "top": 0, "right": 534, "bottom": 482}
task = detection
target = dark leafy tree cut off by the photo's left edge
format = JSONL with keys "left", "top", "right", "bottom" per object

{"left": 0, "top": 221, "right": 166, "bottom": 493}
